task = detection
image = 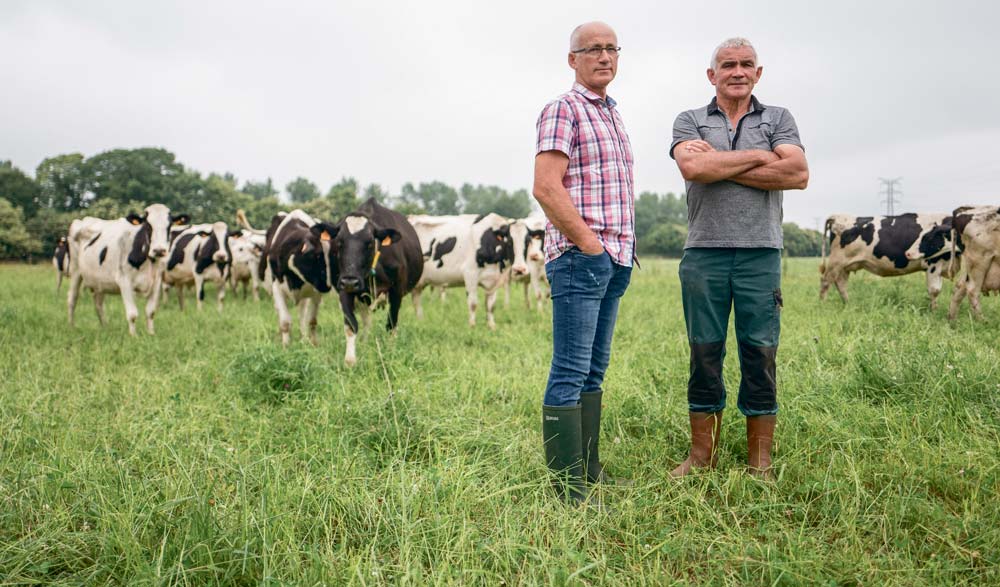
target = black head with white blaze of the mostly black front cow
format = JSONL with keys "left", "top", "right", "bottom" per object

{"left": 334, "top": 214, "right": 402, "bottom": 295}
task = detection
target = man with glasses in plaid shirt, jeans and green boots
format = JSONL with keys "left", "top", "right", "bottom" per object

{"left": 533, "top": 22, "right": 635, "bottom": 503}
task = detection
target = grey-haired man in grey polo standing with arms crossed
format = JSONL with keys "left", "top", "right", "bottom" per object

{"left": 670, "top": 38, "right": 809, "bottom": 477}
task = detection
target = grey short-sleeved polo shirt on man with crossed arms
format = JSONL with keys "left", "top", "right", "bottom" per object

{"left": 670, "top": 96, "right": 802, "bottom": 249}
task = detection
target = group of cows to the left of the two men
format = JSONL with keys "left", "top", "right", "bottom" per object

{"left": 53, "top": 199, "right": 548, "bottom": 365}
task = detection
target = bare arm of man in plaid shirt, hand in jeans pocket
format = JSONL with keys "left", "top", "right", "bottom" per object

{"left": 532, "top": 151, "right": 604, "bottom": 255}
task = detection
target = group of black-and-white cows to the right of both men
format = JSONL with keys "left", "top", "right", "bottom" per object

{"left": 819, "top": 206, "right": 1000, "bottom": 320}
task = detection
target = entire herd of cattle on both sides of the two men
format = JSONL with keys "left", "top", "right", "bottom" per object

{"left": 53, "top": 199, "right": 1000, "bottom": 365}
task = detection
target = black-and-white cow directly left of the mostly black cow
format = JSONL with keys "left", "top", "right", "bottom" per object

{"left": 257, "top": 210, "right": 337, "bottom": 346}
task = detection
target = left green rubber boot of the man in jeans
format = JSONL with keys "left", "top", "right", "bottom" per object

{"left": 542, "top": 405, "right": 588, "bottom": 504}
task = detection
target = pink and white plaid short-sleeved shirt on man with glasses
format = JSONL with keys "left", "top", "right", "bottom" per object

{"left": 535, "top": 83, "right": 635, "bottom": 267}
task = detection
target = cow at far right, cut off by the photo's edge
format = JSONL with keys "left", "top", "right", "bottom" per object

{"left": 948, "top": 206, "right": 1000, "bottom": 320}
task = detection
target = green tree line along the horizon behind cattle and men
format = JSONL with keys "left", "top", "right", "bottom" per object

{"left": 0, "top": 148, "right": 821, "bottom": 260}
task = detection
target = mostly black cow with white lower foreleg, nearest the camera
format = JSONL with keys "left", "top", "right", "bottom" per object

{"left": 334, "top": 198, "right": 424, "bottom": 366}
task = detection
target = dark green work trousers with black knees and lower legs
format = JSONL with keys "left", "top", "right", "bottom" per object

{"left": 680, "top": 248, "right": 782, "bottom": 416}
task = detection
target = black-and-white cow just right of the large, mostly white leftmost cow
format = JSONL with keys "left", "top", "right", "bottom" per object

{"left": 163, "top": 222, "right": 232, "bottom": 312}
